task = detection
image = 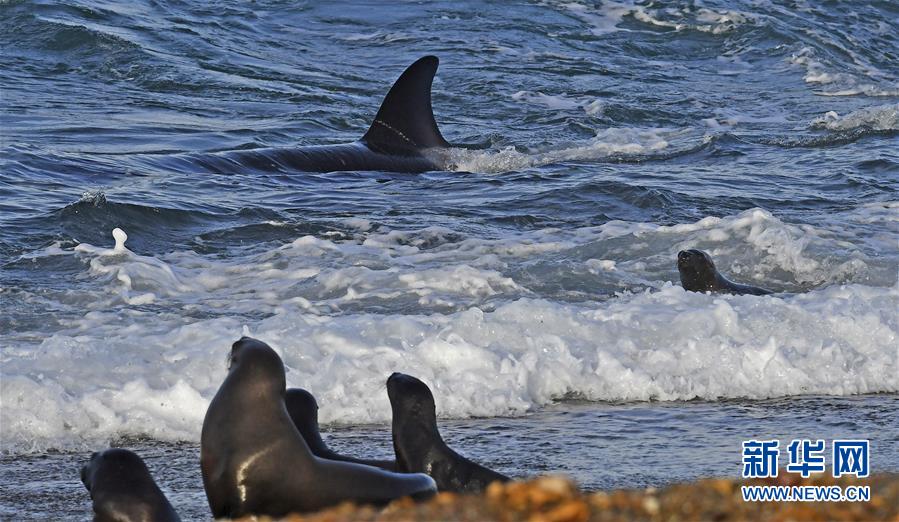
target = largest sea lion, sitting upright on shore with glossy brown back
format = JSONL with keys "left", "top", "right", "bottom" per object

{"left": 200, "top": 337, "right": 437, "bottom": 518}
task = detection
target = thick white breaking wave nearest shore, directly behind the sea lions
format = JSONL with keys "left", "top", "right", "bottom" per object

{"left": 2, "top": 285, "right": 899, "bottom": 453}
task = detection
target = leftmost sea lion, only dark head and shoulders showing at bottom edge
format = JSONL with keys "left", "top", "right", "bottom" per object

{"left": 81, "top": 448, "right": 181, "bottom": 522}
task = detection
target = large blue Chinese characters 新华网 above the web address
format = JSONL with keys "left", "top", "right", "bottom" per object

{"left": 743, "top": 439, "right": 870, "bottom": 478}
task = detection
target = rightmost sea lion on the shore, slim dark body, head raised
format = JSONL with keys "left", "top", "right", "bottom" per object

{"left": 387, "top": 373, "right": 510, "bottom": 492}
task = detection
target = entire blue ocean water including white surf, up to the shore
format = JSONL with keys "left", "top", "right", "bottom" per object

{"left": 0, "top": 0, "right": 899, "bottom": 519}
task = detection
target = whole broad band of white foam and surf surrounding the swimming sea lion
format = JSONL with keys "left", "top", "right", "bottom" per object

{"left": 0, "top": 203, "right": 899, "bottom": 453}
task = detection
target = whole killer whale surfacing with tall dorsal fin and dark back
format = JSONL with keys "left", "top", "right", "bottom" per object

{"left": 208, "top": 56, "right": 450, "bottom": 173}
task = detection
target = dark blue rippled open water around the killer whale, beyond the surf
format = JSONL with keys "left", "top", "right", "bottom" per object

{"left": 0, "top": 2, "right": 899, "bottom": 261}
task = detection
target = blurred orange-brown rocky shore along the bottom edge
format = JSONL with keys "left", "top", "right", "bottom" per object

{"left": 246, "top": 473, "right": 899, "bottom": 522}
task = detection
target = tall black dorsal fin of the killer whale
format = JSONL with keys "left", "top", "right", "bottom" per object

{"left": 362, "top": 56, "right": 450, "bottom": 154}
